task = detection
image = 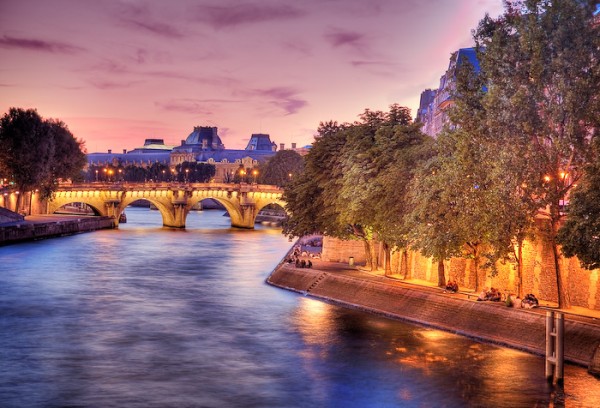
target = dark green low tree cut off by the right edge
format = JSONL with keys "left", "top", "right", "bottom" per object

{"left": 558, "top": 139, "right": 600, "bottom": 269}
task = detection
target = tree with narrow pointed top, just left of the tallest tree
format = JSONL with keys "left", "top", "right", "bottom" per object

{"left": 437, "top": 34, "right": 543, "bottom": 297}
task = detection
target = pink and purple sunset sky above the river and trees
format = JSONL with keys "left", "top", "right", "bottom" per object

{"left": 0, "top": 0, "right": 502, "bottom": 153}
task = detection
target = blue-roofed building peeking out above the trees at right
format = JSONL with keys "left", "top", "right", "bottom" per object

{"left": 416, "top": 48, "right": 480, "bottom": 137}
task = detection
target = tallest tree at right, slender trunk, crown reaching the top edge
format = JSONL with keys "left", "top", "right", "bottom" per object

{"left": 475, "top": 0, "right": 600, "bottom": 308}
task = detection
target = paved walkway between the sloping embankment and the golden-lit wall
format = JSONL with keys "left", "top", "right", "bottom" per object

{"left": 286, "top": 257, "right": 600, "bottom": 325}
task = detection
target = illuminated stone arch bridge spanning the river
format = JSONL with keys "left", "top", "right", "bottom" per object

{"left": 46, "top": 183, "right": 285, "bottom": 228}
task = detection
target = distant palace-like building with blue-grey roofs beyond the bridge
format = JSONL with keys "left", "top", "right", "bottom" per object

{"left": 88, "top": 126, "right": 277, "bottom": 182}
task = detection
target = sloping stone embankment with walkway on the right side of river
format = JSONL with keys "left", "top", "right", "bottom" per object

{"left": 267, "top": 260, "right": 600, "bottom": 374}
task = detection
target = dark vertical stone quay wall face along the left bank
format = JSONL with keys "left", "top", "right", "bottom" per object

{"left": 0, "top": 217, "right": 115, "bottom": 245}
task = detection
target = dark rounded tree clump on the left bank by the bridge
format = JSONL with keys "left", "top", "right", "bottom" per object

{"left": 0, "top": 108, "right": 86, "bottom": 209}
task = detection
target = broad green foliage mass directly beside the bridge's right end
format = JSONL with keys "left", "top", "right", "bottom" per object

{"left": 284, "top": 105, "right": 431, "bottom": 265}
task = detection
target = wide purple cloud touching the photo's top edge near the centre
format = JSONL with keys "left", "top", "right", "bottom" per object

{"left": 195, "top": 3, "right": 306, "bottom": 29}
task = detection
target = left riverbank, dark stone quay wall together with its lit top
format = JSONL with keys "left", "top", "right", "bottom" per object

{"left": 0, "top": 215, "right": 114, "bottom": 246}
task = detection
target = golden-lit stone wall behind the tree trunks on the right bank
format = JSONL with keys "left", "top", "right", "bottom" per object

{"left": 322, "top": 233, "right": 600, "bottom": 310}
